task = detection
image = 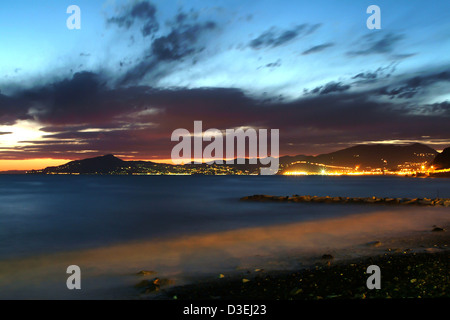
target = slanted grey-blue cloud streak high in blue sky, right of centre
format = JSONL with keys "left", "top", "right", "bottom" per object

{"left": 249, "top": 23, "right": 321, "bottom": 49}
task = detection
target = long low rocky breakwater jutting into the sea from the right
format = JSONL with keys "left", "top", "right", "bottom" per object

{"left": 240, "top": 195, "right": 450, "bottom": 207}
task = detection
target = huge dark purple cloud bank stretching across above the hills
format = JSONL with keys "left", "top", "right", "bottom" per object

{"left": 0, "top": 73, "right": 450, "bottom": 159}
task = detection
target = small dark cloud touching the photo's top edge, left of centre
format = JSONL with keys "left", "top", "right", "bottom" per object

{"left": 107, "top": 1, "right": 159, "bottom": 37}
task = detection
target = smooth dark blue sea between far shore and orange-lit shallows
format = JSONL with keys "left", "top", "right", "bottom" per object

{"left": 0, "top": 175, "right": 450, "bottom": 259}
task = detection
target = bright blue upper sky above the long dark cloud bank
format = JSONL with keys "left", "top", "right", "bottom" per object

{"left": 0, "top": 0, "right": 450, "bottom": 97}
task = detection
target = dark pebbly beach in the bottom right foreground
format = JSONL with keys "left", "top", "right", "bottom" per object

{"left": 153, "top": 232, "right": 450, "bottom": 300}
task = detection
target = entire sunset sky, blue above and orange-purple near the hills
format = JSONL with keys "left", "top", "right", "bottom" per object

{"left": 0, "top": 0, "right": 450, "bottom": 171}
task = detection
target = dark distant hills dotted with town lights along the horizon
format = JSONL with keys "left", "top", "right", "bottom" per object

{"left": 29, "top": 143, "right": 440, "bottom": 174}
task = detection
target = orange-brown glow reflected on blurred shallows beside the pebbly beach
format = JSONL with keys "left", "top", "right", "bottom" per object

{"left": 0, "top": 207, "right": 450, "bottom": 299}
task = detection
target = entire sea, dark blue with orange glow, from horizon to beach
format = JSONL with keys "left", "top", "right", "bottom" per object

{"left": 0, "top": 175, "right": 450, "bottom": 299}
